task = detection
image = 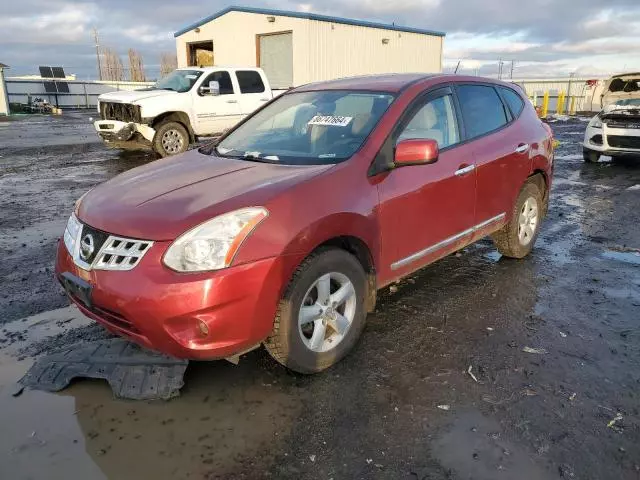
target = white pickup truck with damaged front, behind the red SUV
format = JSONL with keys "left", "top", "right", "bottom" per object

{"left": 94, "top": 67, "right": 273, "bottom": 157}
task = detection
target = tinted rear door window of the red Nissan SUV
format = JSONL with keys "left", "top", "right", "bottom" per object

{"left": 457, "top": 85, "right": 508, "bottom": 139}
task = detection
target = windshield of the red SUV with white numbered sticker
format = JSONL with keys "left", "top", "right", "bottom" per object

{"left": 215, "top": 91, "right": 394, "bottom": 165}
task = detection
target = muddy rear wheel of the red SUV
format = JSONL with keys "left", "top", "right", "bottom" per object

{"left": 491, "top": 181, "right": 544, "bottom": 258}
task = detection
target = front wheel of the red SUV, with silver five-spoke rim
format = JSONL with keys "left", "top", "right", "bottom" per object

{"left": 265, "top": 248, "right": 367, "bottom": 373}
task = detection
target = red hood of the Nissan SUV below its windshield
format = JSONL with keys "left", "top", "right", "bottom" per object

{"left": 76, "top": 150, "right": 332, "bottom": 241}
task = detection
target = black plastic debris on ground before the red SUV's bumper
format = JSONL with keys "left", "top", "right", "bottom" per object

{"left": 20, "top": 338, "right": 189, "bottom": 400}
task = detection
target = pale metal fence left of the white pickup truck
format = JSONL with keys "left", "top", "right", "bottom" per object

{"left": 6, "top": 77, "right": 153, "bottom": 108}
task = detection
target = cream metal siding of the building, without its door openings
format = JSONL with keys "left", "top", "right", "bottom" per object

{"left": 176, "top": 11, "right": 443, "bottom": 86}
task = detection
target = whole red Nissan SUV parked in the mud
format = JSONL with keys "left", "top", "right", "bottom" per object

{"left": 56, "top": 74, "right": 553, "bottom": 373}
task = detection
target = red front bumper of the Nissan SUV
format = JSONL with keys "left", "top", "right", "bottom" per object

{"left": 56, "top": 241, "right": 282, "bottom": 360}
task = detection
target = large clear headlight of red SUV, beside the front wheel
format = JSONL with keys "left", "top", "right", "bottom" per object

{"left": 164, "top": 207, "right": 269, "bottom": 272}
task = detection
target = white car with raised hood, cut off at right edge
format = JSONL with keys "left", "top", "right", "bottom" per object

{"left": 583, "top": 98, "right": 640, "bottom": 163}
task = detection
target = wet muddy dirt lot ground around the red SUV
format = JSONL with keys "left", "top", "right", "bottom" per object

{"left": 0, "top": 113, "right": 640, "bottom": 480}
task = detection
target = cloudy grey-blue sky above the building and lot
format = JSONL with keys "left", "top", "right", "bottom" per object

{"left": 0, "top": 0, "right": 640, "bottom": 79}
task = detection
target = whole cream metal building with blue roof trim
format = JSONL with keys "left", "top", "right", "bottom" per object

{"left": 174, "top": 7, "right": 445, "bottom": 89}
